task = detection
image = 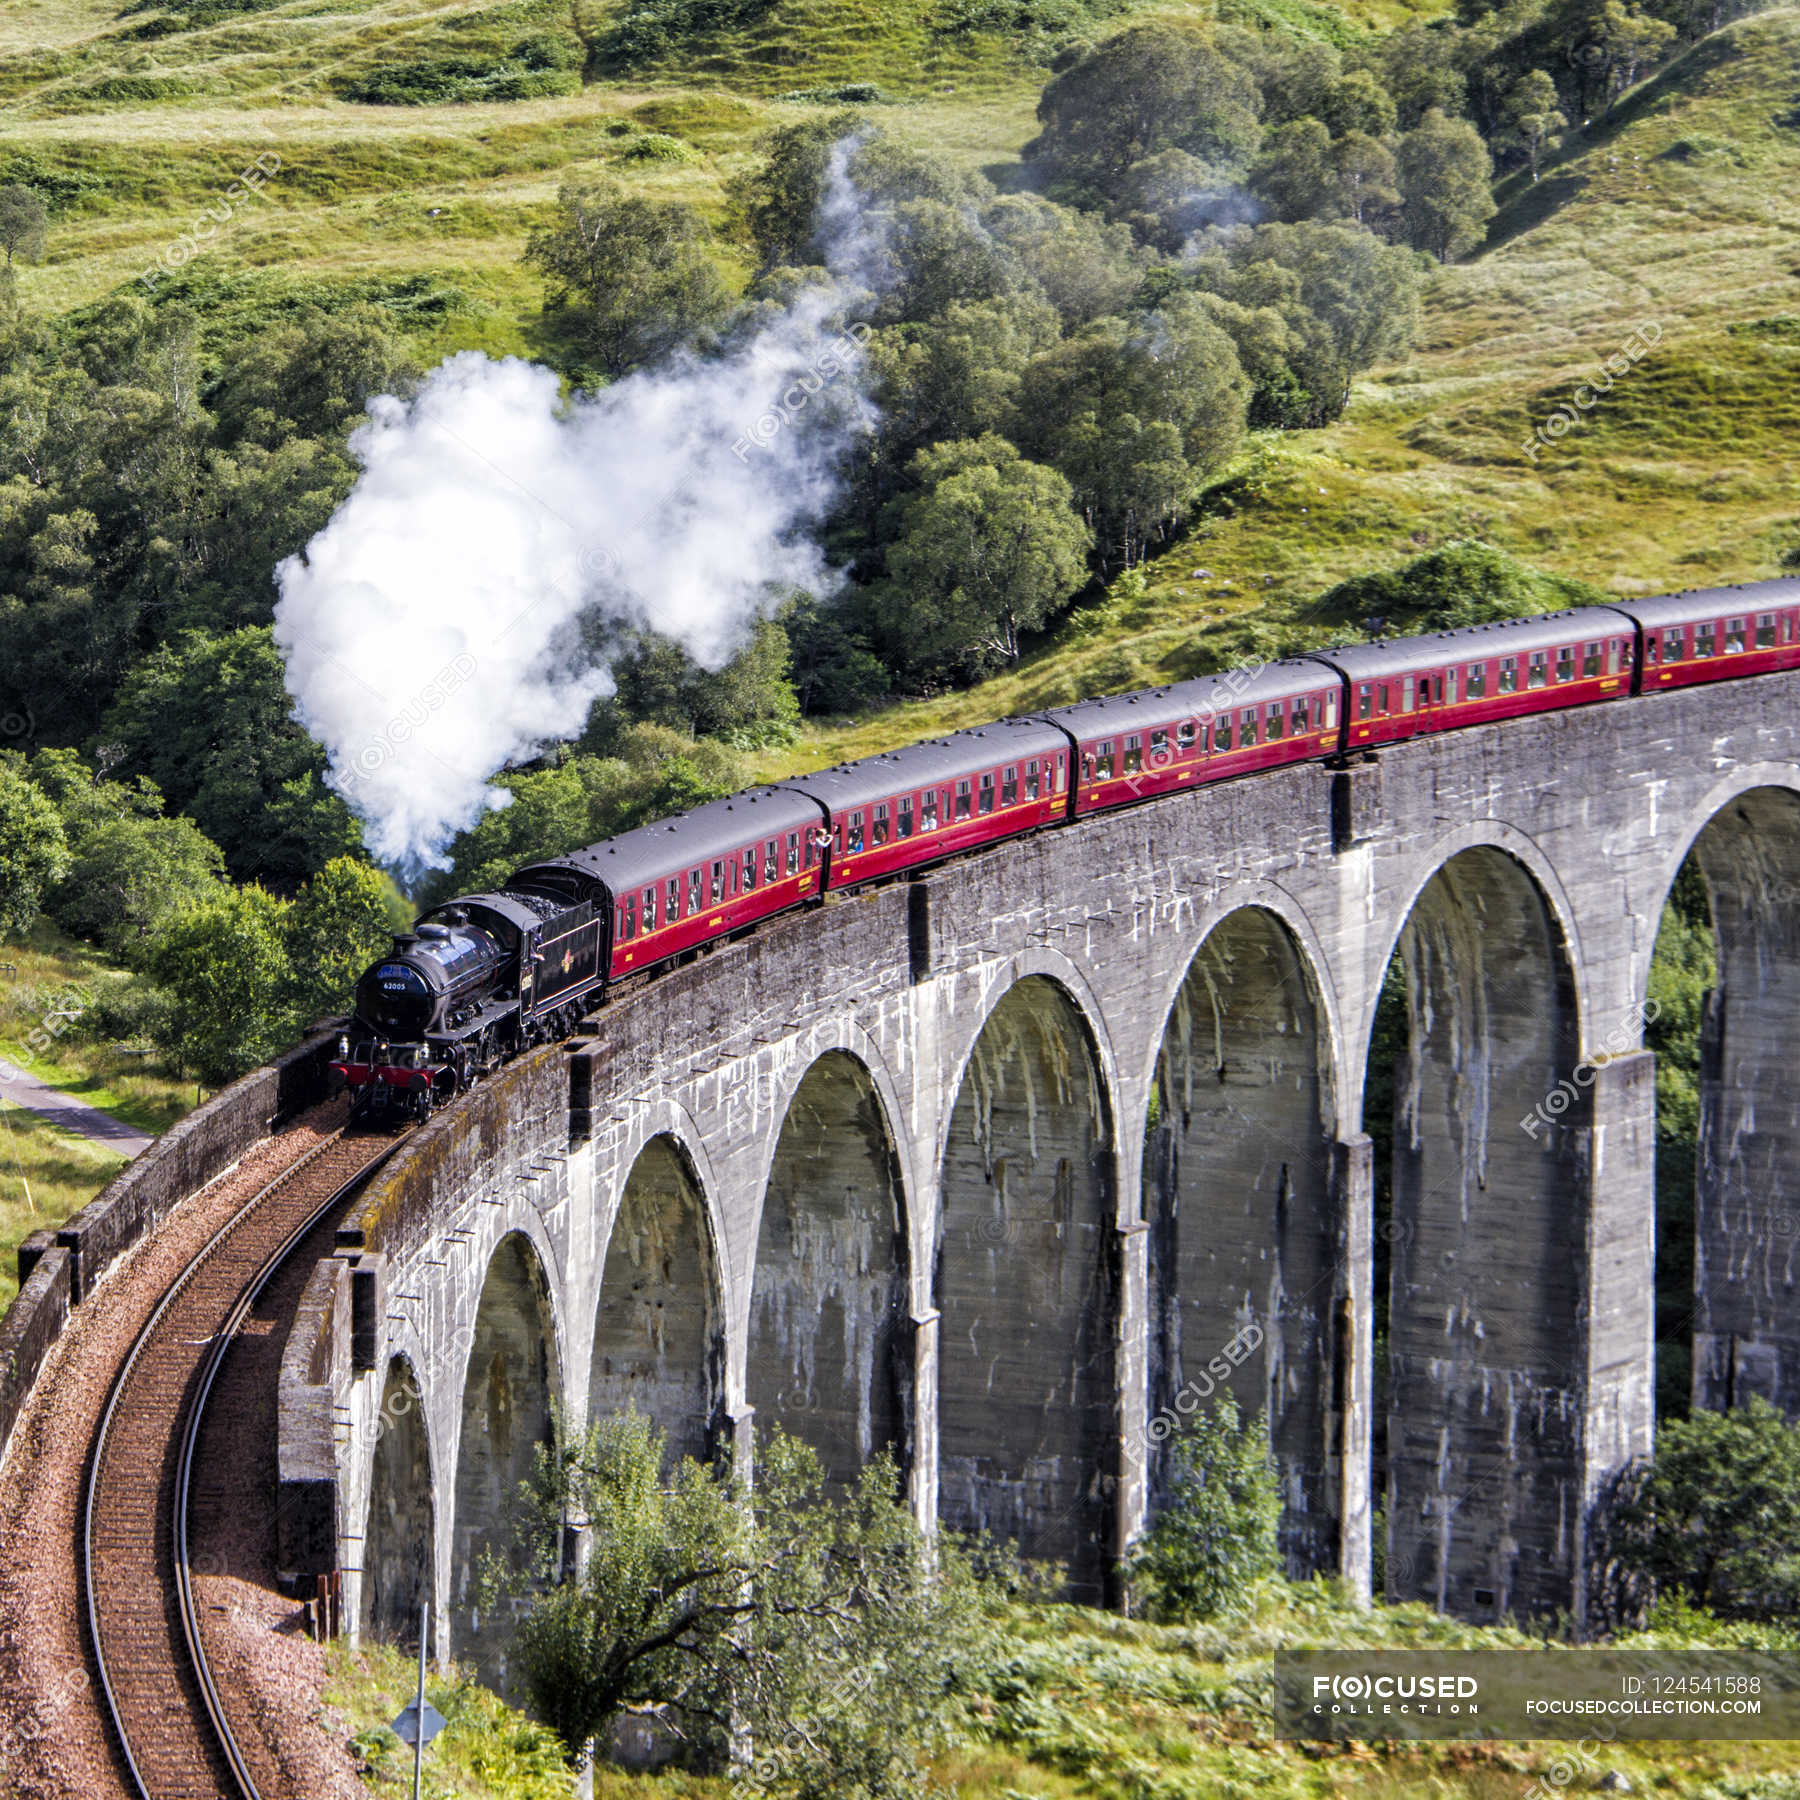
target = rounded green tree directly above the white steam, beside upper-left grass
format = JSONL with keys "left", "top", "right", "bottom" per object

{"left": 526, "top": 180, "right": 727, "bottom": 376}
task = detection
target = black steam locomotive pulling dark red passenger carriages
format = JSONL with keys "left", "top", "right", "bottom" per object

{"left": 333, "top": 581, "right": 1800, "bottom": 1118}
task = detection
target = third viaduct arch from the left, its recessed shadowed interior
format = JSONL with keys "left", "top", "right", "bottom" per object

{"left": 587, "top": 1132, "right": 727, "bottom": 1462}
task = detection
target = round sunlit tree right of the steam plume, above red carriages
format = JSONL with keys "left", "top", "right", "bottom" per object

{"left": 871, "top": 432, "right": 1091, "bottom": 671}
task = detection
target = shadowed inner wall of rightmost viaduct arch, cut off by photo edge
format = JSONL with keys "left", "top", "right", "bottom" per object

{"left": 1670, "top": 770, "right": 1800, "bottom": 1417}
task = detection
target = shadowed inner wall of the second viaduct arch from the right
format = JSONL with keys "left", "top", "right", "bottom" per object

{"left": 1386, "top": 842, "right": 1589, "bottom": 1618}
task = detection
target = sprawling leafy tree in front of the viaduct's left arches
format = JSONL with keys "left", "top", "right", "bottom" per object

{"left": 484, "top": 1409, "right": 977, "bottom": 1800}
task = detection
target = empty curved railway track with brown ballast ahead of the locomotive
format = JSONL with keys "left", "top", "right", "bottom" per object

{"left": 81, "top": 1130, "right": 396, "bottom": 1800}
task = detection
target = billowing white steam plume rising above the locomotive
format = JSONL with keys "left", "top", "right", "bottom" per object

{"left": 275, "top": 162, "right": 869, "bottom": 871}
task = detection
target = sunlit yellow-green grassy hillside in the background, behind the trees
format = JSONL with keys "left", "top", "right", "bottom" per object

{"left": 14, "top": 0, "right": 1800, "bottom": 784}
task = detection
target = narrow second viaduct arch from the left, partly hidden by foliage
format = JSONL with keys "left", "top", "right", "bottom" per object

{"left": 450, "top": 1231, "right": 563, "bottom": 1669}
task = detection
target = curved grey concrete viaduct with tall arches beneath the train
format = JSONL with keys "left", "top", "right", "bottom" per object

{"left": 281, "top": 675, "right": 1800, "bottom": 1652}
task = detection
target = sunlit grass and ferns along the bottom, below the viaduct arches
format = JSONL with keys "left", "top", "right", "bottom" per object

{"left": 326, "top": 1582, "right": 1800, "bottom": 1800}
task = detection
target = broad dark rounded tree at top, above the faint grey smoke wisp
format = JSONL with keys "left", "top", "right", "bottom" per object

{"left": 1024, "top": 23, "right": 1258, "bottom": 202}
